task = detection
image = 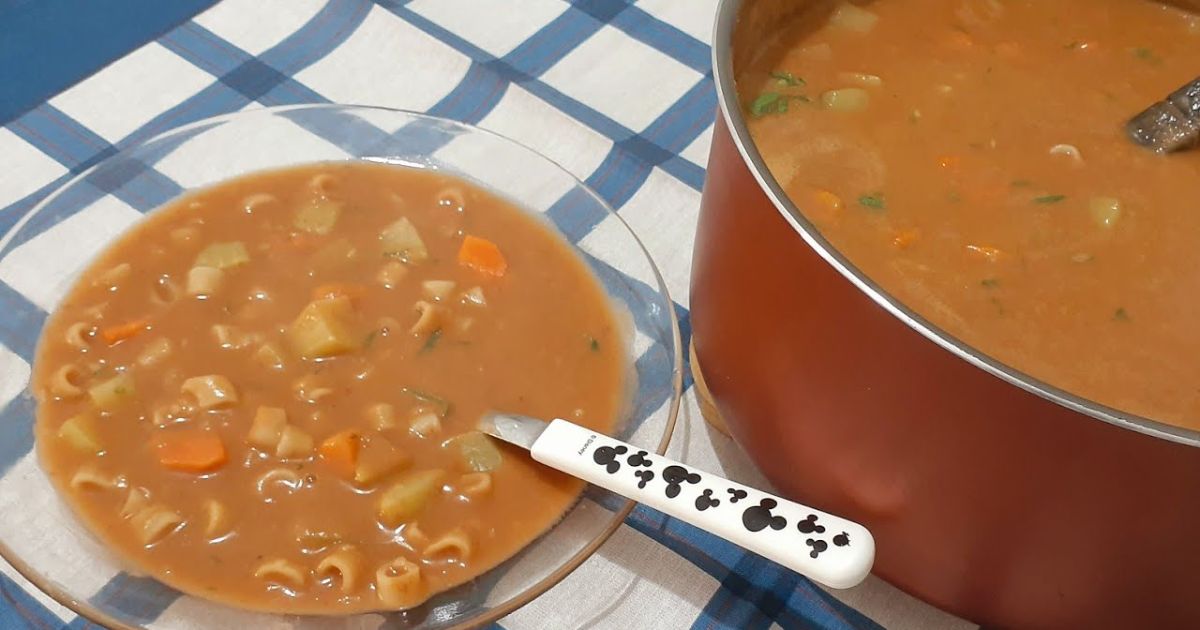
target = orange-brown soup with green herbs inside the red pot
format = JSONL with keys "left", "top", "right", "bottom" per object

{"left": 737, "top": 0, "right": 1200, "bottom": 428}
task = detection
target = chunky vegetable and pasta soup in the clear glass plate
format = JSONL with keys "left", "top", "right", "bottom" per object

{"left": 34, "top": 163, "right": 626, "bottom": 613}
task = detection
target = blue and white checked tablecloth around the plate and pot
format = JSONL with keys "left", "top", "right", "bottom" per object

{"left": 0, "top": 0, "right": 968, "bottom": 629}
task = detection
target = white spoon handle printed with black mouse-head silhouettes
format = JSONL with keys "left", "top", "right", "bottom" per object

{"left": 530, "top": 420, "right": 875, "bottom": 588}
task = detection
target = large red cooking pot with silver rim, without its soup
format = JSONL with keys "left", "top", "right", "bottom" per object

{"left": 691, "top": 0, "right": 1200, "bottom": 628}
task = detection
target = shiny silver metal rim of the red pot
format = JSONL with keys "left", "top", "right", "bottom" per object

{"left": 712, "top": 0, "right": 1200, "bottom": 446}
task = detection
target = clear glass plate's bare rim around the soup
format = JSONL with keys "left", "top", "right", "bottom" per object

{"left": 0, "top": 104, "right": 683, "bottom": 629}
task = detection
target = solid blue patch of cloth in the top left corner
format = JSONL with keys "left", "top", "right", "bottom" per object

{"left": 0, "top": 0, "right": 216, "bottom": 125}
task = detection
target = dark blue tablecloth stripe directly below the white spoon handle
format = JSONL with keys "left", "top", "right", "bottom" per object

{"left": 625, "top": 505, "right": 881, "bottom": 630}
